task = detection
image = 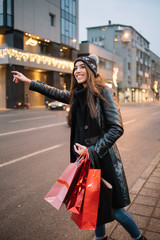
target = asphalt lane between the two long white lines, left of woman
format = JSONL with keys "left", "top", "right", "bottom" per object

{"left": 0, "top": 123, "right": 70, "bottom": 164}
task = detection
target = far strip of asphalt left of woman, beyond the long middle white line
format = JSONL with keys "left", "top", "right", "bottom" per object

{"left": 0, "top": 110, "right": 66, "bottom": 133}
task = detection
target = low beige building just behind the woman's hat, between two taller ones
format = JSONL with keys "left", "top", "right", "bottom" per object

{"left": 79, "top": 41, "right": 123, "bottom": 90}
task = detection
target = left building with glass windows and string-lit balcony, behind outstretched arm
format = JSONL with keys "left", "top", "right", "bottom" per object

{"left": 0, "top": 0, "right": 79, "bottom": 108}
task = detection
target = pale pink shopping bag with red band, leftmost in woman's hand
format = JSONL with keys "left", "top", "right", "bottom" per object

{"left": 44, "top": 149, "right": 87, "bottom": 210}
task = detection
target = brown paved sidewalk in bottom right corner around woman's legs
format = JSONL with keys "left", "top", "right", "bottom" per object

{"left": 93, "top": 152, "right": 160, "bottom": 240}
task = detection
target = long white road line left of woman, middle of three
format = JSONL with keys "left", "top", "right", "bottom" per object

{"left": 0, "top": 122, "right": 66, "bottom": 137}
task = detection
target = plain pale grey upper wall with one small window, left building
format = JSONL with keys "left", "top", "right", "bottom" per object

{"left": 14, "top": 0, "right": 60, "bottom": 43}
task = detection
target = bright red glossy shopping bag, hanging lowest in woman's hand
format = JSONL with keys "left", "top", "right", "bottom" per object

{"left": 71, "top": 169, "right": 101, "bottom": 230}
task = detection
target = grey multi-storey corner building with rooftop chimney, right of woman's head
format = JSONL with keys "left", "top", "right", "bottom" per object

{"left": 87, "top": 21, "right": 152, "bottom": 102}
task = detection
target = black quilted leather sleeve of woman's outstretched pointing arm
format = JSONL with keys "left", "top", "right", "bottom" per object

{"left": 29, "top": 81, "right": 70, "bottom": 104}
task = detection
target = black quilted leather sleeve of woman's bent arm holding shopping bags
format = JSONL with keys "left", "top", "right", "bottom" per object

{"left": 88, "top": 88, "right": 124, "bottom": 158}
